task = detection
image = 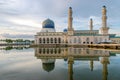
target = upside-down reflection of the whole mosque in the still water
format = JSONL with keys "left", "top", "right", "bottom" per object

{"left": 35, "top": 47, "right": 115, "bottom": 80}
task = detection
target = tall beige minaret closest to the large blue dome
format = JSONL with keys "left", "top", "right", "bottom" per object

{"left": 68, "top": 7, "right": 74, "bottom": 35}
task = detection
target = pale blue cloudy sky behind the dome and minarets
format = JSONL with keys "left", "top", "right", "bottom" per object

{"left": 0, "top": 0, "right": 120, "bottom": 38}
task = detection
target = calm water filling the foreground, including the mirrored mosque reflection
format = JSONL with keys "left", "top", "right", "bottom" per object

{"left": 0, "top": 47, "right": 120, "bottom": 80}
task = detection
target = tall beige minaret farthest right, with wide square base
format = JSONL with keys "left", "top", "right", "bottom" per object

{"left": 101, "top": 6, "right": 109, "bottom": 35}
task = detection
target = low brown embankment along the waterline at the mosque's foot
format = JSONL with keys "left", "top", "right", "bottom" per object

{"left": 30, "top": 44, "right": 120, "bottom": 49}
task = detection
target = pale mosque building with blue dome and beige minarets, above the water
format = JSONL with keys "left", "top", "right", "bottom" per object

{"left": 35, "top": 6, "right": 119, "bottom": 45}
